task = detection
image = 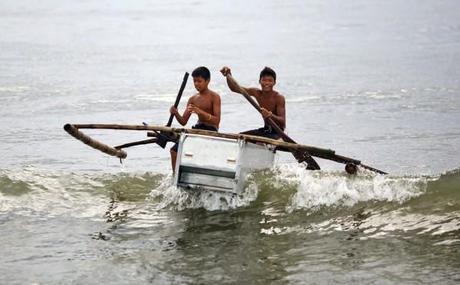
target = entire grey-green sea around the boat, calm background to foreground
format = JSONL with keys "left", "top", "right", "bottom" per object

{"left": 0, "top": 0, "right": 460, "bottom": 284}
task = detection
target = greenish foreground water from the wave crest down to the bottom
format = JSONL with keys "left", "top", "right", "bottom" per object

{"left": 0, "top": 165, "right": 460, "bottom": 284}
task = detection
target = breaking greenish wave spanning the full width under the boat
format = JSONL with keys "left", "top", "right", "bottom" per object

{"left": 0, "top": 164, "right": 460, "bottom": 220}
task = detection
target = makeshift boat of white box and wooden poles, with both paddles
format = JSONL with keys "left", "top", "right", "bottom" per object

{"left": 64, "top": 72, "right": 386, "bottom": 194}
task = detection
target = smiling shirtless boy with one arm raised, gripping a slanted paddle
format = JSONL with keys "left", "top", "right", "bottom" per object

{"left": 220, "top": 66, "right": 286, "bottom": 139}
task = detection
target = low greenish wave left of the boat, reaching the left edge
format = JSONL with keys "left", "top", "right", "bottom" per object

{"left": 0, "top": 166, "right": 161, "bottom": 219}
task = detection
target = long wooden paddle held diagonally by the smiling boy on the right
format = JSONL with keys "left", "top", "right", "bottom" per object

{"left": 226, "top": 74, "right": 321, "bottom": 170}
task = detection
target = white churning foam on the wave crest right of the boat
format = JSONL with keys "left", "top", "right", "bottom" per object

{"left": 278, "top": 164, "right": 427, "bottom": 211}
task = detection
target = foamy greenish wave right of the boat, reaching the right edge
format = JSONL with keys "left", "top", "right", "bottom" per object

{"left": 261, "top": 165, "right": 460, "bottom": 240}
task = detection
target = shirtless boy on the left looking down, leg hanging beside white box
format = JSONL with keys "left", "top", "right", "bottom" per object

{"left": 169, "top": 66, "right": 220, "bottom": 172}
